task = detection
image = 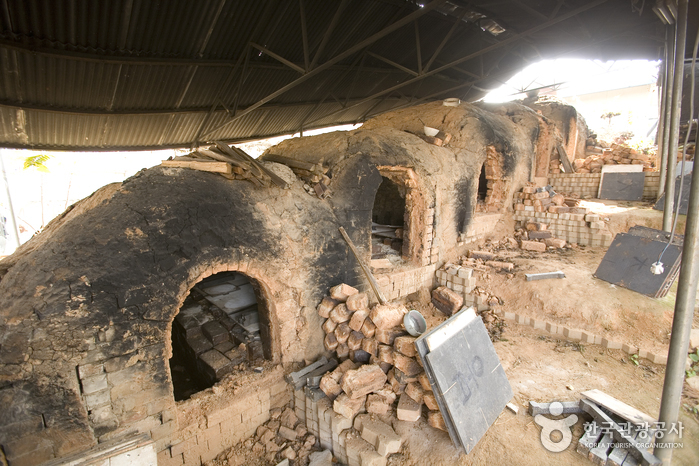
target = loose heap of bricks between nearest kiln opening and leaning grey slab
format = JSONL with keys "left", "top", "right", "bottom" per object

{"left": 318, "top": 284, "right": 443, "bottom": 428}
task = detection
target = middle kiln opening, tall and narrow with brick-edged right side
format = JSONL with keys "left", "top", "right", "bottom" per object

{"left": 371, "top": 176, "right": 406, "bottom": 259}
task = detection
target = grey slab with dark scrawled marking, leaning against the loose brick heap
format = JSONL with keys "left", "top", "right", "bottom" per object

{"left": 417, "top": 308, "right": 513, "bottom": 453}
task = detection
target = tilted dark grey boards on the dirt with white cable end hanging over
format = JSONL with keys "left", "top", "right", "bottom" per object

{"left": 594, "top": 233, "right": 682, "bottom": 298}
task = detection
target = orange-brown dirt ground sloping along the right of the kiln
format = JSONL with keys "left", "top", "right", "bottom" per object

{"left": 208, "top": 203, "right": 699, "bottom": 466}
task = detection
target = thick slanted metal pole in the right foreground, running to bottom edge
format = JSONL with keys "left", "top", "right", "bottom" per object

{"left": 653, "top": 129, "right": 699, "bottom": 465}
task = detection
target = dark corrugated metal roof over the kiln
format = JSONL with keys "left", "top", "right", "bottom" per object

{"left": 0, "top": 0, "right": 680, "bottom": 150}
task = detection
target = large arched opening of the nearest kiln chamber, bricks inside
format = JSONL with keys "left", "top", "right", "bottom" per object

{"left": 170, "top": 272, "right": 272, "bottom": 401}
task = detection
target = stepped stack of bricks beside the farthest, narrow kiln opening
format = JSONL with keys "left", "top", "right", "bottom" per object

{"left": 514, "top": 186, "right": 613, "bottom": 251}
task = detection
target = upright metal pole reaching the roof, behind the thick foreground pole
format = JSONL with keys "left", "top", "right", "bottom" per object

{"left": 663, "top": 0, "right": 688, "bottom": 231}
